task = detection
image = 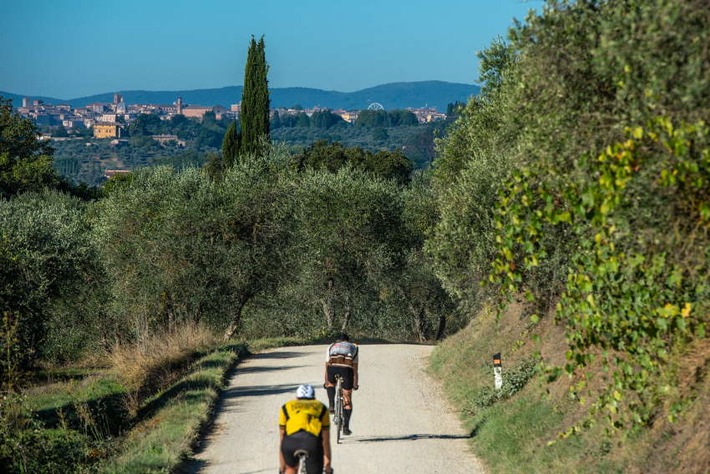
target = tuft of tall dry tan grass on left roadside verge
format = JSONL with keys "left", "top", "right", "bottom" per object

{"left": 109, "top": 324, "right": 221, "bottom": 413}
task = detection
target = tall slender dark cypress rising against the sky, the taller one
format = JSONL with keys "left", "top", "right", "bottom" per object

{"left": 239, "top": 36, "right": 270, "bottom": 155}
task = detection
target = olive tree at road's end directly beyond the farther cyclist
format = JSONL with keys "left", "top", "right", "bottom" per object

{"left": 290, "top": 168, "right": 401, "bottom": 329}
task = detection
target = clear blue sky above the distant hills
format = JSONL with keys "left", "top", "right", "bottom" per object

{"left": 0, "top": 0, "right": 542, "bottom": 99}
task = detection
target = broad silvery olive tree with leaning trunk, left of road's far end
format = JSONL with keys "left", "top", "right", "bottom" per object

{"left": 95, "top": 153, "right": 288, "bottom": 339}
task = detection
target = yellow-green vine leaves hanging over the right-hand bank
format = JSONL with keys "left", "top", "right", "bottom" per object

{"left": 495, "top": 119, "right": 710, "bottom": 426}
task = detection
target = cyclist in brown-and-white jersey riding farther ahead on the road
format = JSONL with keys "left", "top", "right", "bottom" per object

{"left": 323, "top": 333, "right": 359, "bottom": 435}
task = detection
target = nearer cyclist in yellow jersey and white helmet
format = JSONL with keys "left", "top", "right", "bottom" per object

{"left": 279, "top": 385, "right": 333, "bottom": 474}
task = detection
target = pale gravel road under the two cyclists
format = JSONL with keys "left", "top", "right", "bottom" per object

{"left": 187, "top": 344, "right": 483, "bottom": 474}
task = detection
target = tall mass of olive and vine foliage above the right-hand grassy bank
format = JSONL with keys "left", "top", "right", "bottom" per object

{"left": 426, "top": 0, "right": 710, "bottom": 436}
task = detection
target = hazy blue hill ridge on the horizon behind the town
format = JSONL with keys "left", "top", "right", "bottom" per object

{"left": 0, "top": 81, "right": 480, "bottom": 112}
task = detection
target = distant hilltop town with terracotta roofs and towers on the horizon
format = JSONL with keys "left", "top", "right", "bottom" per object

{"left": 17, "top": 93, "right": 446, "bottom": 144}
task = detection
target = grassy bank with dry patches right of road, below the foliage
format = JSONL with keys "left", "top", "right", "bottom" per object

{"left": 431, "top": 305, "right": 710, "bottom": 474}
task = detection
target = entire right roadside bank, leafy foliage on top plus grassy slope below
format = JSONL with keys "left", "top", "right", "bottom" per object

{"left": 426, "top": 0, "right": 710, "bottom": 472}
